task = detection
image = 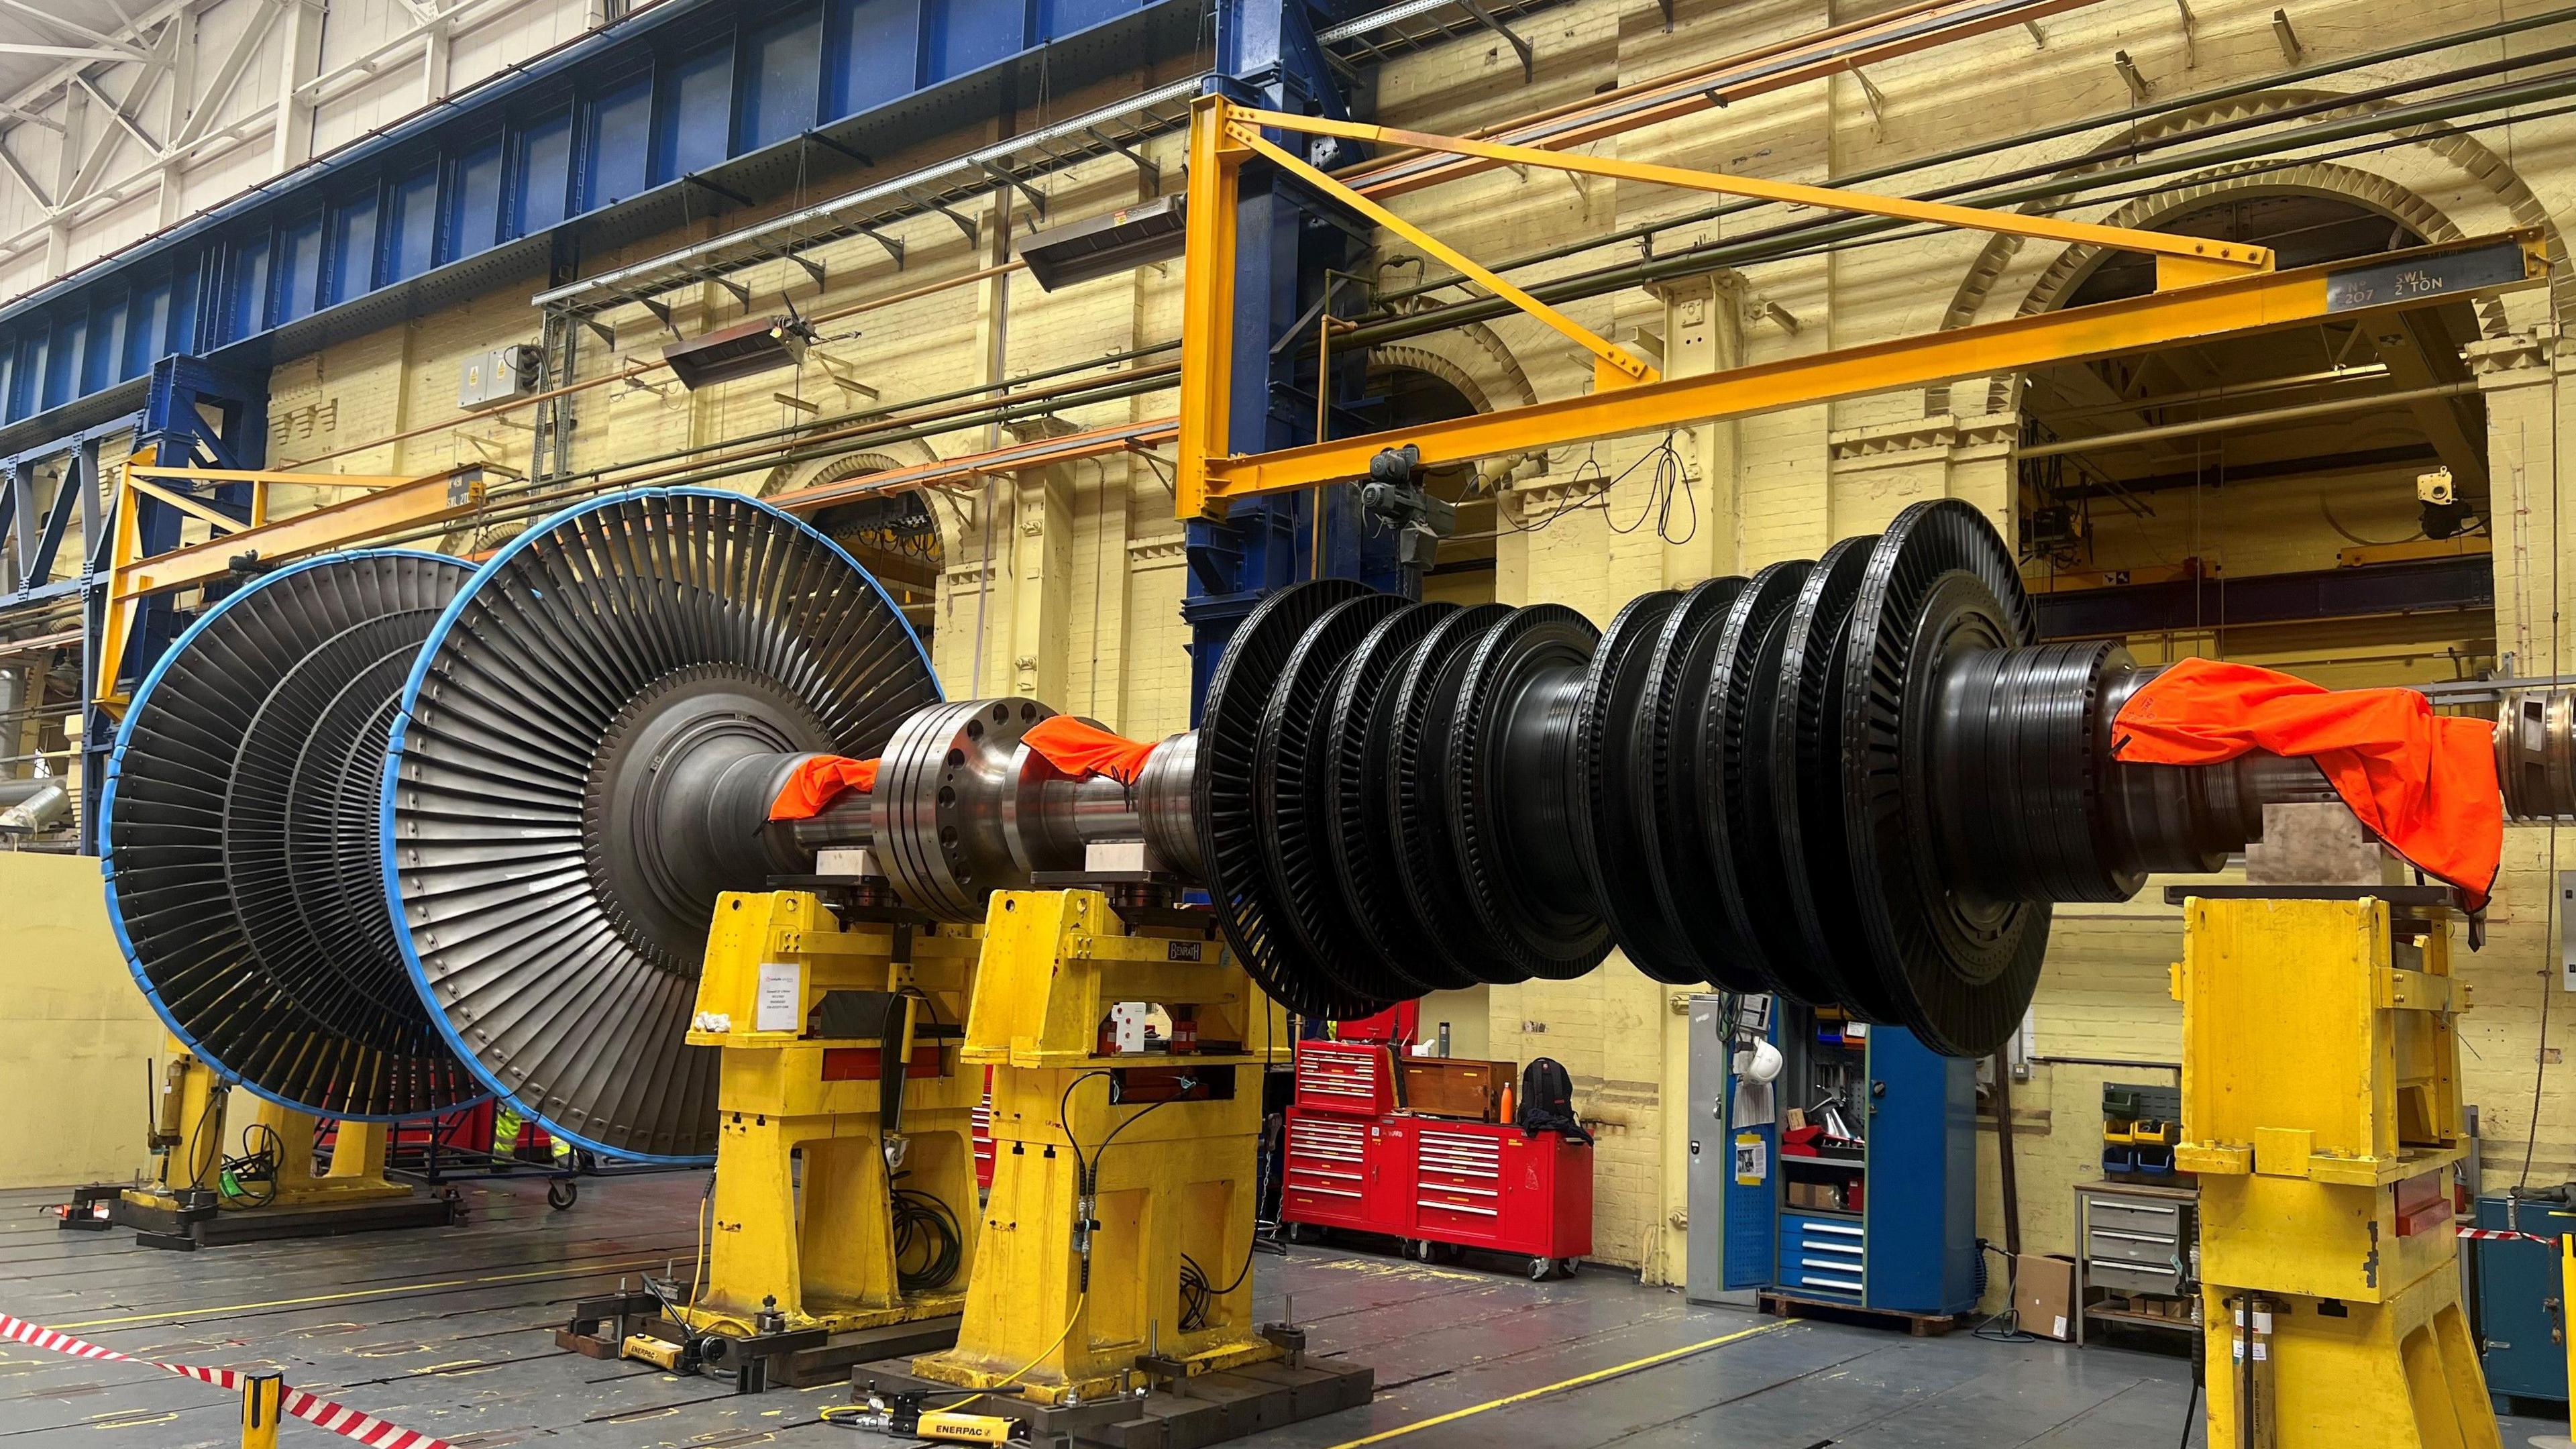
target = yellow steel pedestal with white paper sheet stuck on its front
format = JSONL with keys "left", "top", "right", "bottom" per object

{"left": 672, "top": 890, "right": 984, "bottom": 1338}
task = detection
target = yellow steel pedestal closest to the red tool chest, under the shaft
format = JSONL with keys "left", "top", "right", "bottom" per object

{"left": 912, "top": 890, "right": 1291, "bottom": 1403}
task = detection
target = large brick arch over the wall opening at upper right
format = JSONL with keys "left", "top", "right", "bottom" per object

{"left": 1924, "top": 88, "right": 2576, "bottom": 418}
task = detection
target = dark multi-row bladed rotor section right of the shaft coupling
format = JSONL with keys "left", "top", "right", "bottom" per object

{"left": 1195, "top": 500, "right": 2050, "bottom": 1052}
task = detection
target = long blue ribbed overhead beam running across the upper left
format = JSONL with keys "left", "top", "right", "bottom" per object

{"left": 0, "top": 0, "right": 1200, "bottom": 453}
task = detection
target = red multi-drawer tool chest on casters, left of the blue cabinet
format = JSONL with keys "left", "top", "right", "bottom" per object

{"left": 1280, "top": 1042, "right": 1592, "bottom": 1276}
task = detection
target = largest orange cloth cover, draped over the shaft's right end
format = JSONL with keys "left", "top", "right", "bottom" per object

{"left": 2112, "top": 660, "right": 2504, "bottom": 910}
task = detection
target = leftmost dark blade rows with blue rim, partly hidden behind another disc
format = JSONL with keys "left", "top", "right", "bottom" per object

{"left": 103, "top": 551, "right": 484, "bottom": 1119}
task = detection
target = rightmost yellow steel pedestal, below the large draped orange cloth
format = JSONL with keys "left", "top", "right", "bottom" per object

{"left": 2174, "top": 887, "right": 2499, "bottom": 1449}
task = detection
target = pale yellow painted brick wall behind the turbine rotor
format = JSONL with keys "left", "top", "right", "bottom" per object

{"left": 206, "top": 0, "right": 2576, "bottom": 1279}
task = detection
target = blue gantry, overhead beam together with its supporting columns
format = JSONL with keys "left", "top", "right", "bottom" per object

{"left": 0, "top": 0, "right": 1404, "bottom": 840}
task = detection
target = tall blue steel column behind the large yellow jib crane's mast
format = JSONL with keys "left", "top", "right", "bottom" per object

{"left": 1180, "top": 0, "right": 1404, "bottom": 724}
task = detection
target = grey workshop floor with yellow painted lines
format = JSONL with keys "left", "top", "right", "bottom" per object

{"left": 0, "top": 1173, "right": 2548, "bottom": 1449}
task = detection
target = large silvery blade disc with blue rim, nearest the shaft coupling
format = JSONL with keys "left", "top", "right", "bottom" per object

{"left": 384, "top": 490, "right": 938, "bottom": 1158}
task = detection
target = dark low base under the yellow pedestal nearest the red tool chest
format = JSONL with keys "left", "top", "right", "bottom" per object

{"left": 850, "top": 1358, "right": 1378, "bottom": 1449}
